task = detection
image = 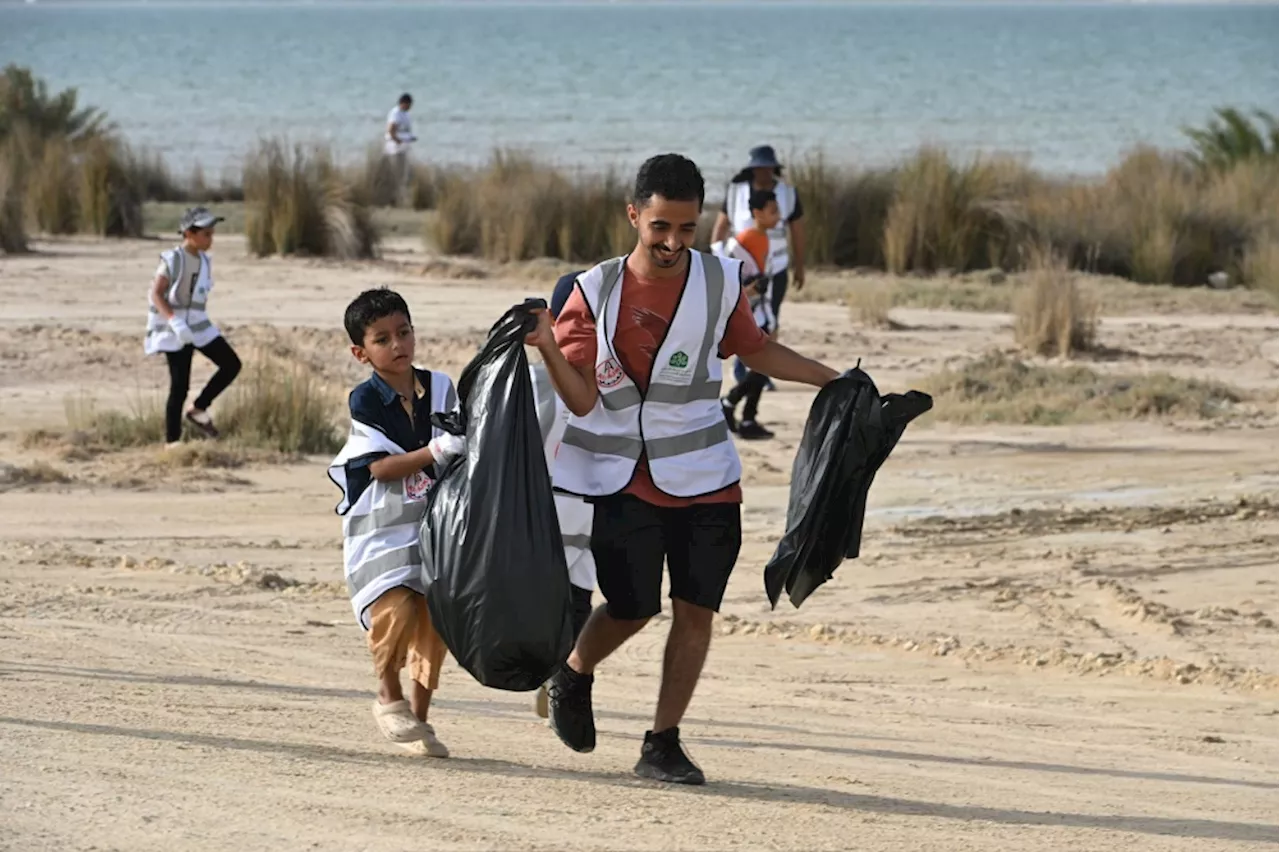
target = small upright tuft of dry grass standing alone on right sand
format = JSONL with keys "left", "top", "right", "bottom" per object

{"left": 1014, "top": 252, "right": 1098, "bottom": 358}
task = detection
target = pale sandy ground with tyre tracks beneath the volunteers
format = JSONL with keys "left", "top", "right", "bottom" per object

{"left": 0, "top": 238, "right": 1280, "bottom": 852}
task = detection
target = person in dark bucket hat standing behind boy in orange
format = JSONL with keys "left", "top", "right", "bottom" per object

{"left": 712, "top": 145, "right": 805, "bottom": 390}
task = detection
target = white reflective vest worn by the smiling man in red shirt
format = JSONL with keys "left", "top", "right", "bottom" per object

{"left": 553, "top": 251, "right": 742, "bottom": 498}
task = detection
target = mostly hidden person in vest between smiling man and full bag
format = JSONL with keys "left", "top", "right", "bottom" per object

{"left": 529, "top": 270, "right": 595, "bottom": 719}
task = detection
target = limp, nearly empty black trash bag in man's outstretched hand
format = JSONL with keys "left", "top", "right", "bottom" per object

{"left": 764, "top": 367, "right": 933, "bottom": 608}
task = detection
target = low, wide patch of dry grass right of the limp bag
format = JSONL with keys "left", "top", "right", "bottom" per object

{"left": 922, "top": 353, "right": 1248, "bottom": 426}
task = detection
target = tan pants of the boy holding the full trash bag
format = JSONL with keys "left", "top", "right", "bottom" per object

{"left": 369, "top": 586, "right": 448, "bottom": 690}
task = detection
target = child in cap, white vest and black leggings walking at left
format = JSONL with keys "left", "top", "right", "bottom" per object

{"left": 143, "top": 207, "right": 241, "bottom": 446}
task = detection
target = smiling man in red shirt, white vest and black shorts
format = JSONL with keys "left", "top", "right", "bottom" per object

{"left": 527, "top": 154, "right": 836, "bottom": 784}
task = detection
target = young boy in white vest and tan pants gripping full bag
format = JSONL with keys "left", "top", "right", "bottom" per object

{"left": 329, "top": 288, "right": 466, "bottom": 757}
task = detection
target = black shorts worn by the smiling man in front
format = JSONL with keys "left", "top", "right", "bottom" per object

{"left": 591, "top": 494, "right": 742, "bottom": 620}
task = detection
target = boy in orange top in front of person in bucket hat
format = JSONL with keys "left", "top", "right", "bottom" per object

{"left": 712, "top": 189, "right": 781, "bottom": 441}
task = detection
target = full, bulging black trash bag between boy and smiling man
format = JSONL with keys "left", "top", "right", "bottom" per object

{"left": 419, "top": 299, "right": 573, "bottom": 691}
